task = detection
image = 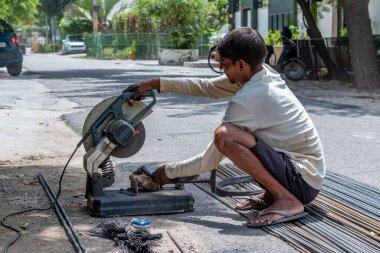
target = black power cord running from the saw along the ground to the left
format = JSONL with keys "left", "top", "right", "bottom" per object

{"left": 1, "top": 131, "right": 90, "bottom": 253}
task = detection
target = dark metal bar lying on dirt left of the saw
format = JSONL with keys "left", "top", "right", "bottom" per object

{"left": 37, "top": 174, "right": 86, "bottom": 253}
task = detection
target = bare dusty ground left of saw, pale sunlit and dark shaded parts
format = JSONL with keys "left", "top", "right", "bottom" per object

{"left": 0, "top": 81, "right": 184, "bottom": 253}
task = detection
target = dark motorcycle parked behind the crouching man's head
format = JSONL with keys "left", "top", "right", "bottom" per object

{"left": 208, "top": 28, "right": 306, "bottom": 81}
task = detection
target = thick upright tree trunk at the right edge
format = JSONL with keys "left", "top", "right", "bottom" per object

{"left": 342, "top": 0, "right": 380, "bottom": 89}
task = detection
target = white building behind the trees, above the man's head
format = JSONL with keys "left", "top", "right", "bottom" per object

{"left": 229, "top": 0, "right": 380, "bottom": 37}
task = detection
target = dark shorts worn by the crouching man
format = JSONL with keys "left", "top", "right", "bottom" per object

{"left": 251, "top": 140, "right": 319, "bottom": 204}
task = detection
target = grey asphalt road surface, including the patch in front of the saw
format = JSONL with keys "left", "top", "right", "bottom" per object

{"left": 0, "top": 54, "right": 380, "bottom": 252}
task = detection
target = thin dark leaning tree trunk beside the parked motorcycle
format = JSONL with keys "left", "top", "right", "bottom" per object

{"left": 297, "top": 0, "right": 339, "bottom": 79}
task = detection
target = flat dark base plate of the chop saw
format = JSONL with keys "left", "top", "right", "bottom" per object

{"left": 87, "top": 189, "right": 194, "bottom": 218}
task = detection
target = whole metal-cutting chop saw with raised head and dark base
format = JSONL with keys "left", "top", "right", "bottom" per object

{"left": 82, "top": 91, "right": 193, "bottom": 217}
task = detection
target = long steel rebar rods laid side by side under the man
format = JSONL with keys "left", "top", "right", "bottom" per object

{"left": 196, "top": 164, "right": 380, "bottom": 253}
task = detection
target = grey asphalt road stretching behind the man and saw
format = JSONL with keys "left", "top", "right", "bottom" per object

{"left": 20, "top": 52, "right": 380, "bottom": 187}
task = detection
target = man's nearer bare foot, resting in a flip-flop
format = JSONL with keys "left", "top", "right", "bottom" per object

{"left": 247, "top": 198, "right": 304, "bottom": 225}
